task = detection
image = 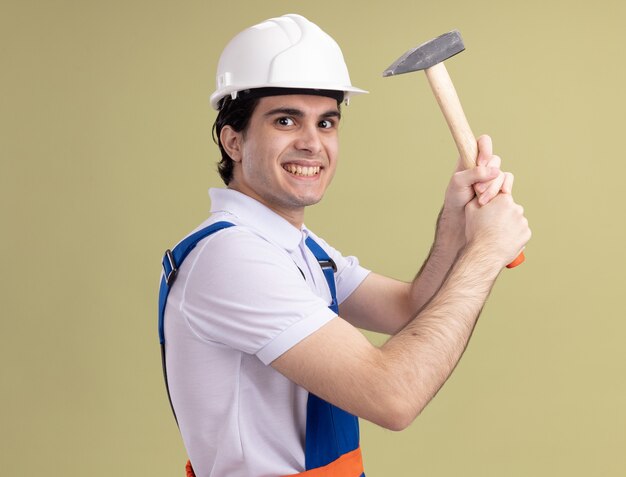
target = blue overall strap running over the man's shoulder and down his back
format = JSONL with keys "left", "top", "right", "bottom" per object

{"left": 159, "top": 222, "right": 235, "bottom": 344}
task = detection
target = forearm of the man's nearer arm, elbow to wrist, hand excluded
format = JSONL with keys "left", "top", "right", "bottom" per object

{"left": 381, "top": 244, "right": 500, "bottom": 429}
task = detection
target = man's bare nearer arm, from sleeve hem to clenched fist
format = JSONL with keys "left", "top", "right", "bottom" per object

{"left": 272, "top": 188, "right": 530, "bottom": 430}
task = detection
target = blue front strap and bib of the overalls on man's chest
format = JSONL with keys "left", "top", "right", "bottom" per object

{"left": 305, "top": 237, "right": 365, "bottom": 477}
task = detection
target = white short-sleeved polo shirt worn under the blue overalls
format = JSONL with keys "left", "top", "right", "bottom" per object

{"left": 165, "top": 189, "right": 369, "bottom": 477}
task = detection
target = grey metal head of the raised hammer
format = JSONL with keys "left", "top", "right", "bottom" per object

{"left": 383, "top": 30, "right": 465, "bottom": 76}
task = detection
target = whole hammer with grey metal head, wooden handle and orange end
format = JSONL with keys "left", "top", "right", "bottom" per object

{"left": 383, "top": 30, "right": 525, "bottom": 268}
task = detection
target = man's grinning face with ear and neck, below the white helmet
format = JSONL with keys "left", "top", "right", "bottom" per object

{"left": 229, "top": 95, "right": 340, "bottom": 227}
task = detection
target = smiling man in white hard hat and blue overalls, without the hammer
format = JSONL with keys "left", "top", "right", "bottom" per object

{"left": 162, "top": 15, "right": 530, "bottom": 477}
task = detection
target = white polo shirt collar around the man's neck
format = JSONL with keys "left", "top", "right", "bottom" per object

{"left": 209, "top": 188, "right": 308, "bottom": 252}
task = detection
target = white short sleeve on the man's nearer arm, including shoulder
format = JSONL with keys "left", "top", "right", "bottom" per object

{"left": 181, "top": 226, "right": 336, "bottom": 364}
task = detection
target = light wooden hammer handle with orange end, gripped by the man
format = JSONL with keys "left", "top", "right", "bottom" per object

{"left": 425, "top": 62, "right": 525, "bottom": 268}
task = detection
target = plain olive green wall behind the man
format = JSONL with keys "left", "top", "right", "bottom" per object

{"left": 0, "top": 0, "right": 626, "bottom": 477}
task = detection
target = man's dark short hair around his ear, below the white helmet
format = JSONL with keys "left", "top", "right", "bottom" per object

{"left": 213, "top": 96, "right": 259, "bottom": 185}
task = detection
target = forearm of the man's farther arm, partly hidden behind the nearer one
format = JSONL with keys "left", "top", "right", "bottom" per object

{"left": 409, "top": 208, "right": 465, "bottom": 316}
